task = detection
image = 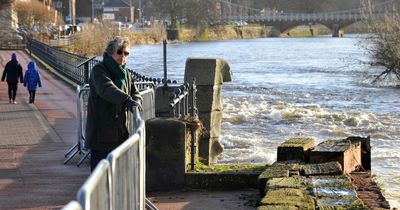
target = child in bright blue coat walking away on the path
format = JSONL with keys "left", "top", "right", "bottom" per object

{"left": 24, "top": 61, "right": 42, "bottom": 104}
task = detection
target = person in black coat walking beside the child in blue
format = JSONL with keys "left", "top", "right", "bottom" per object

{"left": 1, "top": 53, "right": 23, "bottom": 104}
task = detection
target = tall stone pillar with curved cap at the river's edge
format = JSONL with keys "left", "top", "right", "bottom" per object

{"left": 184, "top": 58, "right": 232, "bottom": 165}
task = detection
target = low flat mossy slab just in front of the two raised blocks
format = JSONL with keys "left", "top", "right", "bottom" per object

{"left": 302, "top": 161, "right": 343, "bottom": 176}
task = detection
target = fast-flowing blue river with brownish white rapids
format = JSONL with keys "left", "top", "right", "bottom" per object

{"left": 128, "top": 35, "right": 400, "bottom": 207}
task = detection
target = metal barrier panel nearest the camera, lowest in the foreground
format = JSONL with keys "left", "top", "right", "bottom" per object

{"left": 77, "top": 160, "right": 113, "bottom": 210}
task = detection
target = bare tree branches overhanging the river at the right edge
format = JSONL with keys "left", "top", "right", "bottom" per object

{"left": 363, "top": 0, "right": 400, "bottom": 82}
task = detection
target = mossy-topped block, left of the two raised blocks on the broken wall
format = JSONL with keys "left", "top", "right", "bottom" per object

{"left": 277, "top": 138, "right": 315, "bottom": 162}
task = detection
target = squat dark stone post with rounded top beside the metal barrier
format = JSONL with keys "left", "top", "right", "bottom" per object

{"left": 146, "top": 118, "right": 186, "bottom": 190}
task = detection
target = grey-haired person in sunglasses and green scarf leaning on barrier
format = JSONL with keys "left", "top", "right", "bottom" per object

{"left": 85, "top": 36, "right": 142, "bottom": 171}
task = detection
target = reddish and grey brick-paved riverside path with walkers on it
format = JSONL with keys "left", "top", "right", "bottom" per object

{"left": 0, "top": 51, "right": 90, "bottom": 210}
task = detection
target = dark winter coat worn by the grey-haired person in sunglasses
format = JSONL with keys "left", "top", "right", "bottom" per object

{"left": 85, "top": 61, "right": 142, "bottom": 150}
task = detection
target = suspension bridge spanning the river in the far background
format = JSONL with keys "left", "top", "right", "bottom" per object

{"left": 216, "top": 0, "right": 396, "bottom": 37}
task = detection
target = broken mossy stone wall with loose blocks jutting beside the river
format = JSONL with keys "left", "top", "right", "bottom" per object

{"left": 258, "top": 137, "right": 390, "bottom": 210}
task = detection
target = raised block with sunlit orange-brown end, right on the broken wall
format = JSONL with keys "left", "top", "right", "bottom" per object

{"left": 310, "top": 140, "right": 361, "bottom": 173}
